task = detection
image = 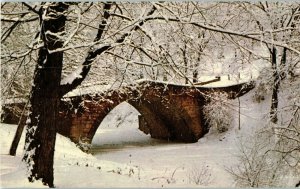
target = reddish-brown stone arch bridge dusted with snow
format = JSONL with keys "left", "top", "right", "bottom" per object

{"left": 2, "top": 80, "right": 254, "bottom": 143}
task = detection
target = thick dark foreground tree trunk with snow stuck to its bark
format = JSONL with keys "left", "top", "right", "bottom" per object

{"left": 23, "top": 3, "right": 68, "bottom": 187}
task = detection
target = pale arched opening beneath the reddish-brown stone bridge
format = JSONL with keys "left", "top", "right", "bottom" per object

{"left": 91, "top": 102, "right": 151, "bottom": 149}
